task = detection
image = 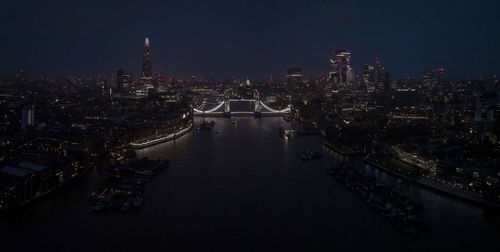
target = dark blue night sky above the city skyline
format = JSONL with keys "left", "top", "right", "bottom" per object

{"left": 0, "top": 0, "right": 500, "bottom": 79}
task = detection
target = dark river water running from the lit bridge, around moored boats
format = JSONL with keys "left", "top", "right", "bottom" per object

{"left": 0, "top": 117, "right": 500, "bottom": 251}
